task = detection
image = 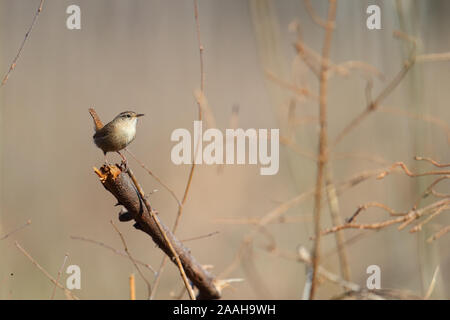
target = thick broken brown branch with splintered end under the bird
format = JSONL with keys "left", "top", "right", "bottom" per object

{"left": 95, "top": 165, "right": 220, "bottom": 299}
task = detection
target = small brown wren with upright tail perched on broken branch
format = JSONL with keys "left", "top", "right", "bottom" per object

{"left": 89, "top": 108, "right": 144, "bottom": 164}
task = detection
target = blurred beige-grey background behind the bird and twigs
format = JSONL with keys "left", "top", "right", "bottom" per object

{"left": 0, "top": 0, "right": 450, "bottom": 299}
